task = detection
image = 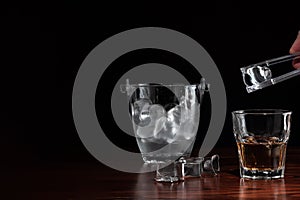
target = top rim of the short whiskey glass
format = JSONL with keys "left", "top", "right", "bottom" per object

{"left": 232, "top": 108, "right": 292, "bottom": 115}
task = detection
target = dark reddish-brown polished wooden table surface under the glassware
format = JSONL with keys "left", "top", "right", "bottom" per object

{"left": 0, "top": 147, "right": 300, "bottom": 200}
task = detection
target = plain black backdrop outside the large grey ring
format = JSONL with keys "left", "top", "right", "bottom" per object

{"left": 0, "top": 1, "right": 300, "bottom": 162}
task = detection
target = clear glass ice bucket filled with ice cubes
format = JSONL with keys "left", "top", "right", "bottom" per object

{"left": 121, "top": 78, "right": 209, "bottom": 163}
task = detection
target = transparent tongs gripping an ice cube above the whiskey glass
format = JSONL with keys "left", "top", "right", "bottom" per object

{"left": 240, "top": 52, "right": 300, "bottom": 93}
